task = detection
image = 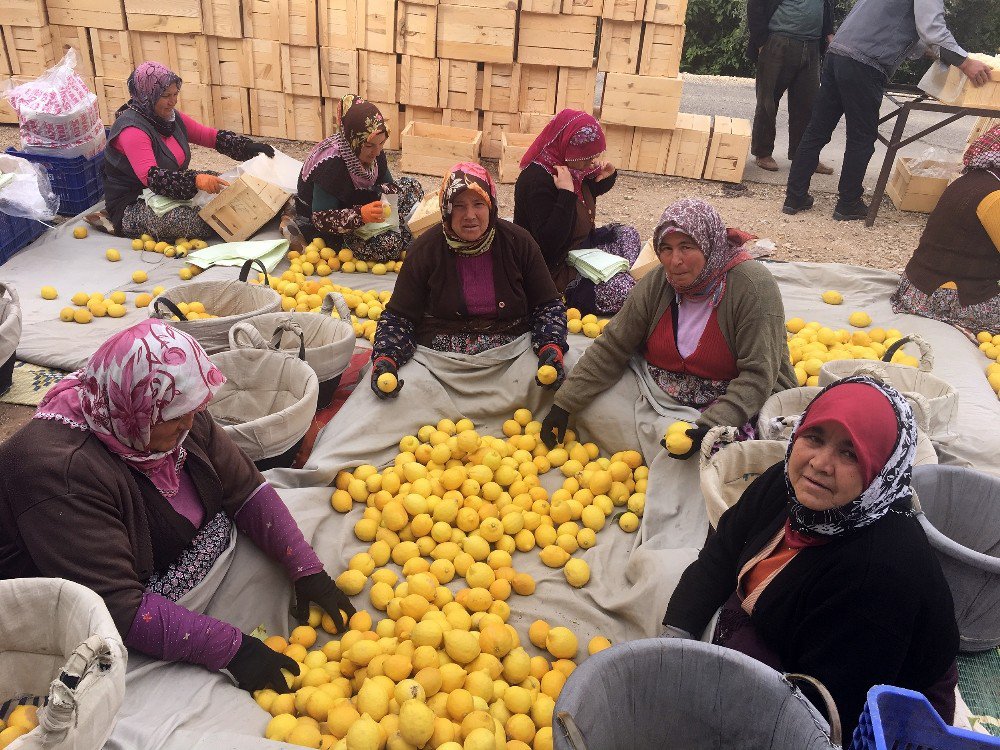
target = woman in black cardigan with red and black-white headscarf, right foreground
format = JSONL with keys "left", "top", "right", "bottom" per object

{"left": 663, "top": 377, "right": 958, "bottom": 737}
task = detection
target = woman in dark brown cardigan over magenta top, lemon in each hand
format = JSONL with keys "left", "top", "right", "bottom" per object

{"left": 371, "top": 163, "right": 568, "bottom": 399}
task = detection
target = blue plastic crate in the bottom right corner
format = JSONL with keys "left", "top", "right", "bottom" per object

{"left": 851, "top": 685, "right": 1000, "bottom": 750}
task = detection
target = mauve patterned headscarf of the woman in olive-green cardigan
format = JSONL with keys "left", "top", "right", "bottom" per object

{"left": 653, "top": 198, "right": 751, "bottom": 307}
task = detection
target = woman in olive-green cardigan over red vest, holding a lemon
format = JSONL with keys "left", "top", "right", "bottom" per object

{"left": 542, "top": 198, "right": 796, "bottom": 458}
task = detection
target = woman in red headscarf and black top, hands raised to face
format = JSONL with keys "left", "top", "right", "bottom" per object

{"left": 514, "top": 109, "right": 640, "bottom": 315}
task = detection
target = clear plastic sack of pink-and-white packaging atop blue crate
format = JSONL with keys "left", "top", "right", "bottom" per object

{"left": 3, "top": 48, "right": 107, "bottom": 158}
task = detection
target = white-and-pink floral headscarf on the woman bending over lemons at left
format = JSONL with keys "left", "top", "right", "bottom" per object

{"left": 34, "top": 319, "right": 226, "bottom": 497}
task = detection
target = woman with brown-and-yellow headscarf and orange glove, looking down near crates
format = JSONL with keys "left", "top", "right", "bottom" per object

{"left": 292, "top": 94, "right": 424, "bottom": 263}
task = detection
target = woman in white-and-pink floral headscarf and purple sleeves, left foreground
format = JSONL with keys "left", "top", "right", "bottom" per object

{"left": 0, "top": 320, "right": 354, "bottom": 691}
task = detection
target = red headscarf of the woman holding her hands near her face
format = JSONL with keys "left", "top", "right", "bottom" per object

{"left": 521, "top": 109, "right": 608, "bottom": 198}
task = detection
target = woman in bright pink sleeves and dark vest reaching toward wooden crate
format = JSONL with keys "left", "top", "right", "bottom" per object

{"left": 87, "top": 62, "right": 274, "bottom": 242}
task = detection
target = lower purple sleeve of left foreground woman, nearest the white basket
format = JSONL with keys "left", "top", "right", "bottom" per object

{"left": 125, "top": 594, "right": 243, "bottom": 671}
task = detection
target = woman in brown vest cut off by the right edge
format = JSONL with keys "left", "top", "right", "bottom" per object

{"left": 892, "top": 125, "right": 1000, "bottom": 334}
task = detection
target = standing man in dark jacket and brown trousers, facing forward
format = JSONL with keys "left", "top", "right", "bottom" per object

{"left": 747, "top": 0, "right": 833, "bottom": 174}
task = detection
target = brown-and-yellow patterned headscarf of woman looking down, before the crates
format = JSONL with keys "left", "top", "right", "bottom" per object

{"left": 302, "top": 94, "right": 389, "bottom": 190}
